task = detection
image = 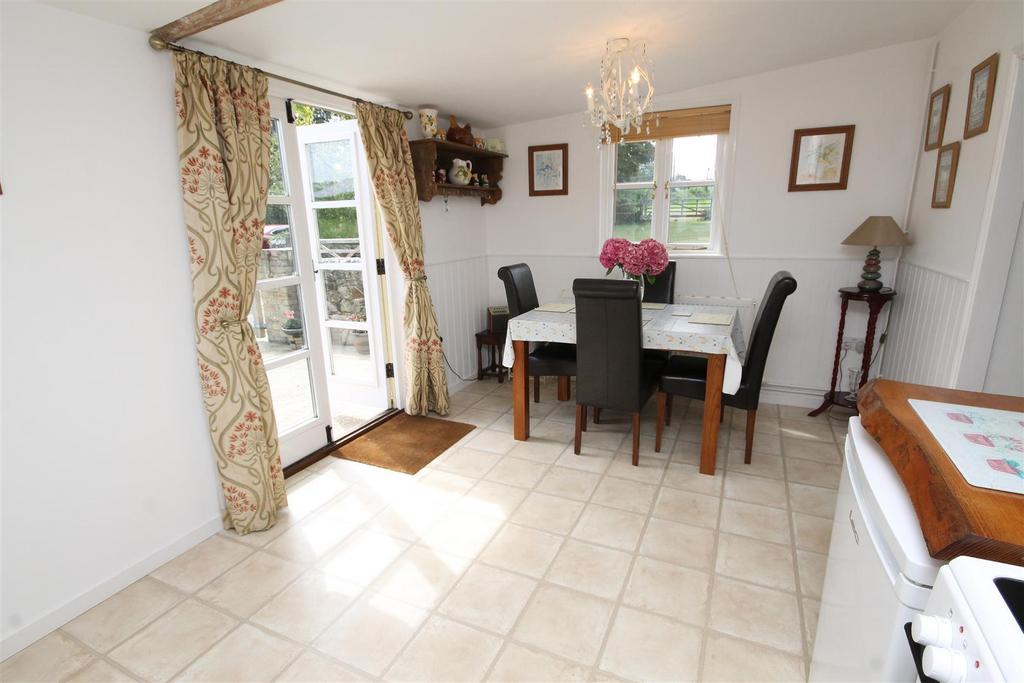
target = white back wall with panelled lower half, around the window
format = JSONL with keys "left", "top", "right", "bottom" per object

{"left": 487, "top": 41, "right": 932, "bottom": 404}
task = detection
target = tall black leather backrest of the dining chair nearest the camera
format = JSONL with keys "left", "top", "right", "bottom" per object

{"left": 572, "top": 279, "right": 643, "bottom": 413}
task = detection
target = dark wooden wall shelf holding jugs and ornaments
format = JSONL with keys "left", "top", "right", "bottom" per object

{"left": 409, "top": 139, "right": 508, "bottom": 206}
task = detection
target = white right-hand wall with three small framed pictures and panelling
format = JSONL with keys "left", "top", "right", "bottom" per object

{"left": 884, "top": 2, "right": 1024, "bottom": 390}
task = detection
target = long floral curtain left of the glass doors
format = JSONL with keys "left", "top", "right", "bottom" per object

{"left": 174, "top": 52, "right": 288, "bottom": 533}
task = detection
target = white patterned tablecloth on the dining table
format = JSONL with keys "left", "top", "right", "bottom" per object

{"left": 503, "top": 299, "right": 744, "bottom": 394}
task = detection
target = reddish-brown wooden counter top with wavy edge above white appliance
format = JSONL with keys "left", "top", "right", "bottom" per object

{"left": 857, "top": 380, "right": 1024, "bottom": 566}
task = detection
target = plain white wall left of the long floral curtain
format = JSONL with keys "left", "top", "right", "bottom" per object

{"left": 0, "top": 2, "right": 220, "bottom": 654}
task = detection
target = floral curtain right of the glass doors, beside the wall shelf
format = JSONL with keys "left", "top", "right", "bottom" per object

{"left": 355, "top": 102, "right": 449, "bottom": 415}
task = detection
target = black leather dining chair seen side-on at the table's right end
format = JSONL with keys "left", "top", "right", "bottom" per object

{"left": 654, "top": 270, "right": 797, "bottom": 464}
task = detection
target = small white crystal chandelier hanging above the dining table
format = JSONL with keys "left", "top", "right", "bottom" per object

{"left": 586, "top": 38, "right": 654, "bottom": 142}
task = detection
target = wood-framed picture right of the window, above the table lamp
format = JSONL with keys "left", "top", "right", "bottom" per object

{"left": 790, "top": 126, "right": 854, "bottom": 193}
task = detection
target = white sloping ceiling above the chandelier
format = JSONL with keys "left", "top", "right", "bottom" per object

{"left": 49, "top": 0, "right": 970, "bottom": 128}
